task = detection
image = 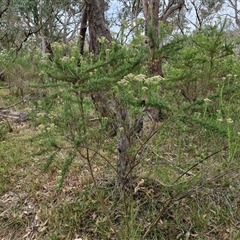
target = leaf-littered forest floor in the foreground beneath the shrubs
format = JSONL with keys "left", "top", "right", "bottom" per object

{"left": 0, "top": 89, "right": 240, "bottom": 240}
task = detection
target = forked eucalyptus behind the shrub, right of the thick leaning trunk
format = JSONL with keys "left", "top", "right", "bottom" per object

{"left": 107, "top": 0, "right": 185, "bottom": 76}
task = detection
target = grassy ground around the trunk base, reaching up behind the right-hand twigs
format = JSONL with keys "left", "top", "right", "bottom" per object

{"left": 0, "top": 76, "right": 240, "bottom": 240}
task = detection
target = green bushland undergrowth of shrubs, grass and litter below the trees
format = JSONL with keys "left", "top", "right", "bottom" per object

{"left": 0, "top": 25, "right": 240, "bottom": 239}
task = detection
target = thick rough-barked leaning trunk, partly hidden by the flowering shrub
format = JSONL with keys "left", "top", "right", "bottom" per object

{"left": 82, "top": 0, "right": 141, "bottom": 193}
